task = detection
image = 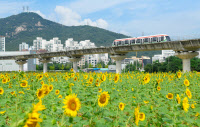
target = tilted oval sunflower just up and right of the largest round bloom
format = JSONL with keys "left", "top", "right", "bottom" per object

{"left": 98, "top": 91, "right": 110, "bottom": 107}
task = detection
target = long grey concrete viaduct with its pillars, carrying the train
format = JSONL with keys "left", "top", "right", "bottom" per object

{"left": 0, "top": 39, "right": 200, "bottom": 73}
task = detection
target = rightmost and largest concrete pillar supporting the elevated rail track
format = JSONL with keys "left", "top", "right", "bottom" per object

{"left": 175, "top": 51, "right": 199, "bottom": 72}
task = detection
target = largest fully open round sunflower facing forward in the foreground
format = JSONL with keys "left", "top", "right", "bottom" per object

{"left": 63, "top": 94, "right": 81, "bottom": 117}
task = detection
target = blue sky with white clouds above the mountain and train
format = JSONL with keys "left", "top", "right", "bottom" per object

{"left": 0, "top": 0, "right": 200, "bottom": 39}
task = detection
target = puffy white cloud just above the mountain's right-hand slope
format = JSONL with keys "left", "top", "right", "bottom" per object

{"left": 55, "top": 6, "right": 108, "bottom": 29}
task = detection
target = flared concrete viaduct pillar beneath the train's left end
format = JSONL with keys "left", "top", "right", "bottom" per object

{"left": 110, "top": 54, "right": 126, "bottom": 74}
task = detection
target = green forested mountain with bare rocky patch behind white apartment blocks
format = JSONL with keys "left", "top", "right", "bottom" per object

{"left": 0, "top": 12, "right": 158, "bottom": 56}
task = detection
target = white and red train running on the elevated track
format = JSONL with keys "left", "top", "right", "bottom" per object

{"left": 112, "top": 34, "right": 171, "bottom": 46}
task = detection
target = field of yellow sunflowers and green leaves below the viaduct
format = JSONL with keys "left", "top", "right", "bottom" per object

{"left": 0, "top": 70, "right": 200, "bottom": 127}
